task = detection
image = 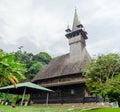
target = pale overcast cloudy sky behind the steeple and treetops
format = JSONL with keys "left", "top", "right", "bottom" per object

{"left": 0, "top": 0, "right": 120, "bottom": 57}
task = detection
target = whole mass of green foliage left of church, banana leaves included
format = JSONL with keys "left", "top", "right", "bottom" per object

{"left": 0, "top": 50, "right": 52, "bottom": 101}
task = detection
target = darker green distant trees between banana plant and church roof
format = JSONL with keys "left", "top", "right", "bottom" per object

{"left": 15, "top": 50, "right": 52, "bottom": 80}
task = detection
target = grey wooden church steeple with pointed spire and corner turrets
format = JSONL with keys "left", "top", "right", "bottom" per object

{"left": 65, "top": 9, "right": 87, "bottom": 62}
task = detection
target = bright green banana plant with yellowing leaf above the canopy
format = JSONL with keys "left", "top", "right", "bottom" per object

{"left": 0, "top": 51, "right": 26, "bottom": 87}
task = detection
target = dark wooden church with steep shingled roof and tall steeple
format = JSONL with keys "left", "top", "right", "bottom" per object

{"left": 32, "top": 10, "right": 91, "bottom": 104}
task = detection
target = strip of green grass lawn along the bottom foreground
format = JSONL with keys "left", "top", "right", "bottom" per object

{"left": 0, "top": 105, "right": 120, "bottom": 112}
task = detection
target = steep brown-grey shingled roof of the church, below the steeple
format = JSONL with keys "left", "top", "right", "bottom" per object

{"left": 32, "top": 48, "right": 91, "bottom": 82}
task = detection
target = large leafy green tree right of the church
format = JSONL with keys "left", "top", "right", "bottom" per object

{"left": 84, "top": 54, "right": 120, "bottom": 106}
